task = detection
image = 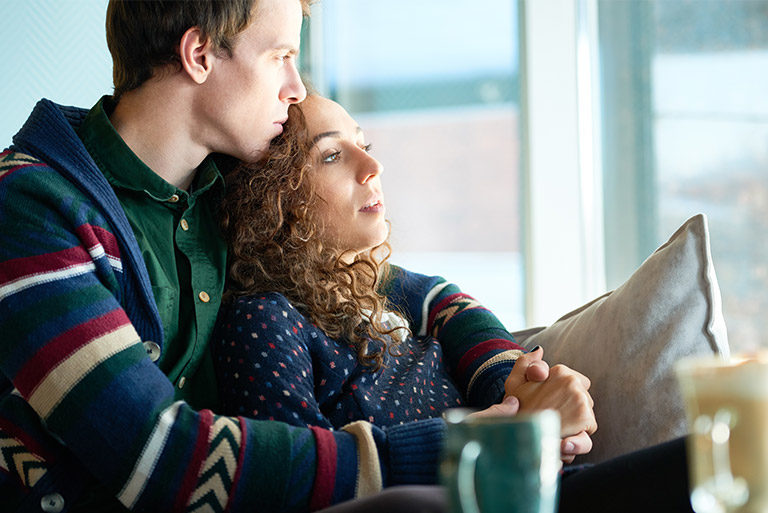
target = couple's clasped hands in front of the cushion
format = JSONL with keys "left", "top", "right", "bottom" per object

{"left": 473, "top": 348, "right": 597, "bottom": 463}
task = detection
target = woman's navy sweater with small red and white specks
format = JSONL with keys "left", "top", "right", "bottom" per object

{"left": 212, "top": 293, "right": 464, "bottom": 429}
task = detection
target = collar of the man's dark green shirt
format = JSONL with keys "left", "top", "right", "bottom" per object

{"left": 78, "top": 96, "right": 224, "bottom": 202}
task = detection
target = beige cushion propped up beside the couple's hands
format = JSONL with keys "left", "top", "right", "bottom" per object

{"left": 516, "top": 214, "right": 729, "bottom": 462}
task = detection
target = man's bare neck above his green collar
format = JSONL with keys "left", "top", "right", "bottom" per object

{"left": 109, "top": 80, "right": 209, "bottom": 190}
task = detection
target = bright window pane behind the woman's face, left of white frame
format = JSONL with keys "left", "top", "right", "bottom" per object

{"left": 305, "top": 0, "right": 525, "bottom": 329}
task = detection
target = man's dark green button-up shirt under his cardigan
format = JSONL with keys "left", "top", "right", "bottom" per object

{"left": 78, "top": 96, "right": 227, "bottom": 409}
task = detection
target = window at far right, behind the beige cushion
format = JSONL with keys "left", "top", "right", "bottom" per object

{"left": 599, "top": 0, "right": 768, "bottom": 350}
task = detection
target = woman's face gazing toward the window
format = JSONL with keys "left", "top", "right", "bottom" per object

{"left": 301, "top": 96, "right": 388, "bottom": 260}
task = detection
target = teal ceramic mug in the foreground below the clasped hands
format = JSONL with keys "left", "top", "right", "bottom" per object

{"left": 440, "top": 410, "right": 561, "bottom": 513}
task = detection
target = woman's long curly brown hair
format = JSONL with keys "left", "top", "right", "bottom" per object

{"left": 221, "top": 97, "right": 407, "bottom": 370}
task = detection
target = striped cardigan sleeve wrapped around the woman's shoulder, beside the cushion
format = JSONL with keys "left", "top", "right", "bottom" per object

{"left": 382, "top": 266, "right": 524, "bottom": 408}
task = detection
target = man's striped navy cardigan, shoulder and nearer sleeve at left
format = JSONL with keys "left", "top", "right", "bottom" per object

{"left": 0, "top": 100, "right": 513, "bottom": 512}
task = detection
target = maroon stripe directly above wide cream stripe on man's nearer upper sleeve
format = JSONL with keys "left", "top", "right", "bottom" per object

{"left": 13, "top": 308, "right": 131, "bottom": 399}
